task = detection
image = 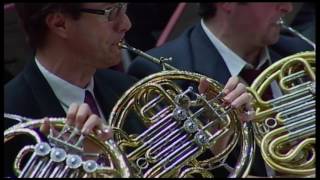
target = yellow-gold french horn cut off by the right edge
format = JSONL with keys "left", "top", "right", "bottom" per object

{"left": 248, "top": 21, "right": 316, "bottom": 177}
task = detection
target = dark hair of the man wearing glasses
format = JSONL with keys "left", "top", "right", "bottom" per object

{"left": 15, "top": 3, "right": 81, "bottom": 49}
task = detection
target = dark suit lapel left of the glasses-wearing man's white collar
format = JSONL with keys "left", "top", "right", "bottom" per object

{"left": 24, "top": 61, "right": 66, "bottom": 117}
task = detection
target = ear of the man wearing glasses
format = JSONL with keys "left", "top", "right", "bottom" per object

{"left": 46, "top": 12, "right": 67, "bottom": 38}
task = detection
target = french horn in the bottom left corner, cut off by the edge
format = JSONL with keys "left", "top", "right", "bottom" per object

{"left": 4, "top": 113, "right": 132, "bottom": 178}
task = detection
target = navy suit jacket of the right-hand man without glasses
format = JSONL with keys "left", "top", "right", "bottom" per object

{"left": 128, "top": 23, "right": 313, "bottom": 176}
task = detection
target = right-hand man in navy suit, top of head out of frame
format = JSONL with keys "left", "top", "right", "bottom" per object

{"left": 128, "top": 3, "right": 312, "bottom": 84}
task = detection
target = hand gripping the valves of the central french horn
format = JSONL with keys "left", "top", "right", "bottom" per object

{"left": 198, "top": 76, "right": 255, "bottom": 122}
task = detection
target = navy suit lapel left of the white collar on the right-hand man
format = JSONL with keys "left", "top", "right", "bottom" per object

{"left": 190, "top": 24, "right": 231, "bottom": 84}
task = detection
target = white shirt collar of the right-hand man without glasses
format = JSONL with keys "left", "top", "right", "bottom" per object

{"left": 201, "top": 19, "right": 271, "bottom": 76}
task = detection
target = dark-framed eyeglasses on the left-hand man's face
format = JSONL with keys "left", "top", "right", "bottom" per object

{"left": 80, "top": 3, "right": 127, "bottom": 22}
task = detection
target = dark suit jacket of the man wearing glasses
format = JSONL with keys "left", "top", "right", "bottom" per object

{"left": 4, "top": 61, "right": 136, "bottom": 176}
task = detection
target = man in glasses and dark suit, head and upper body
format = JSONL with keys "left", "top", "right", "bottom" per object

{"left": 4, "top": 3, "right": 134, "bottom": 124}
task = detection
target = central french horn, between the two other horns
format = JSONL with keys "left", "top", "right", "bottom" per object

{"left": 109, "top": 42, "right": 255, "bottom": 178}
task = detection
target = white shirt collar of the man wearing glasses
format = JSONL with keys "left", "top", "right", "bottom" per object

{"left": 35, "top": 58, "right": 94, "bottom": 112}
